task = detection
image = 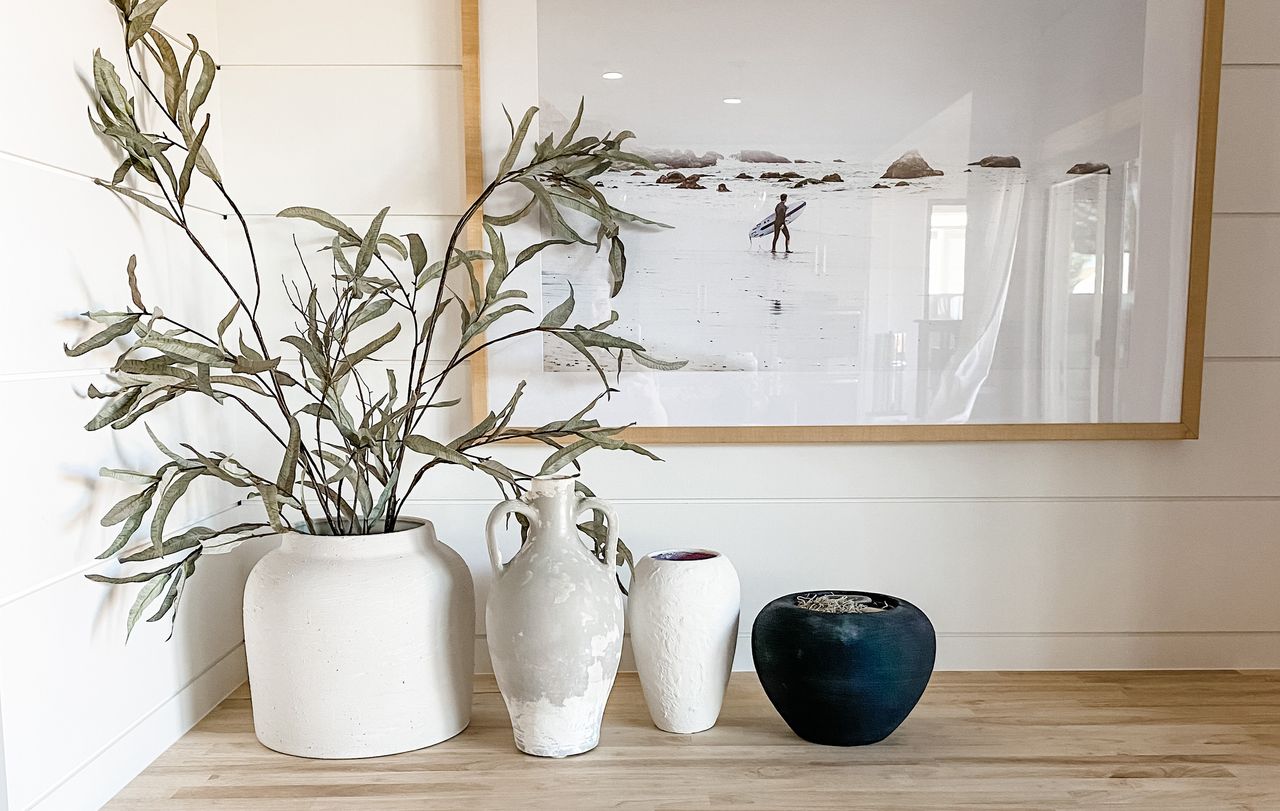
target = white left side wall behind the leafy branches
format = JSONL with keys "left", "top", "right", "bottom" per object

{"left": 0, "top": 0, "right": 270, "bottom": 810}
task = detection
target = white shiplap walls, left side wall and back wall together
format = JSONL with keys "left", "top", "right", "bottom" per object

{"left": 0, "top": 0, "right": 1280, "bottom": 808}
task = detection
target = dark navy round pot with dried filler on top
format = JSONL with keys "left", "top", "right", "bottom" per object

{"left": 751, "top": 591, "right": 937, "bottom": 746}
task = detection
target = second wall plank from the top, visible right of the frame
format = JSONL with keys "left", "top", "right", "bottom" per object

{"left": 1213, "top": 67, "right": 1280, "bottom": 214}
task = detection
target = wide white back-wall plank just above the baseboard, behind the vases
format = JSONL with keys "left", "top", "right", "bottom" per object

{"left": 407, "top": 501, "right": 1280, "bottom": 637}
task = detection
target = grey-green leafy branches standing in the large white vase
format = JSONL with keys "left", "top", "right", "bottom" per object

{"left": 73, "top": 0, "right": 684, "bottom": 632}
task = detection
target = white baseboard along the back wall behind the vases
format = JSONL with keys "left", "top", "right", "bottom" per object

{"left": 476, "top": 631, "right": 1280, "bottom": 673}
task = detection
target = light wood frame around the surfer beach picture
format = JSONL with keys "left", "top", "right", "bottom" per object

{"left": 460, "top": 0, "right": 1225, "bottom": 444}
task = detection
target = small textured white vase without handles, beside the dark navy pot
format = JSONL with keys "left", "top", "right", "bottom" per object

{"left": 627, "top": 549, "right": 741, "bottom": 733}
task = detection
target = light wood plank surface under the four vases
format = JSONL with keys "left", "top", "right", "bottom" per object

{"left": 108, "top": 672, "right": 1280, "bottom": 811}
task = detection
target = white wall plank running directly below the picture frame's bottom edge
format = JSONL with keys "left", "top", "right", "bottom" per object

{"left": 399, "top": 362, "right": 1280, "bottom": 501}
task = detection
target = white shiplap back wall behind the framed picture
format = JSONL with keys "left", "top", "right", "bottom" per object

{"left": 207, "top": 0, "right": 1280, "bottom": 668}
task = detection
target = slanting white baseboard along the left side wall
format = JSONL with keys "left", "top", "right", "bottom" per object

{"left": 29, "top": 643, "right": 247, "bottom": 811}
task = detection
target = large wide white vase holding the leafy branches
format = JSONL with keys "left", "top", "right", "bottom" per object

{"left": 244, "top": 519, "right": 475, "bottom": 757}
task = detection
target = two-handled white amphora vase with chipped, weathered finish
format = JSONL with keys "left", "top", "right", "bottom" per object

{"left": 485, "top": 476, "right": 623, "bottom": 757}
